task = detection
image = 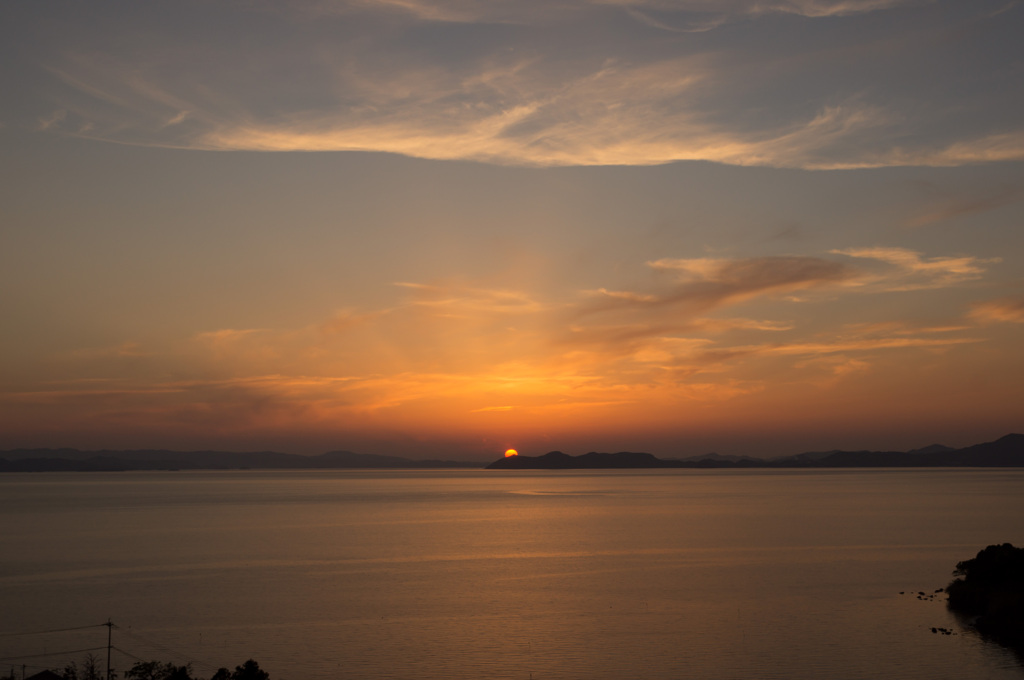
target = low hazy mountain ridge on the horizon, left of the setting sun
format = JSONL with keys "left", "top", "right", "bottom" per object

{"left": 0, "top": 449, "right": 479, "bottom": 472}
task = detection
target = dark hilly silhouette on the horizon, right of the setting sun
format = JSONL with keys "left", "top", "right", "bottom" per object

{"left": 486, "top": 434, "right": 1024, "bottom": 470}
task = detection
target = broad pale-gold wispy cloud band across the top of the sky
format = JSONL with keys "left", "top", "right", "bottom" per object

{"left": 19, "top": 0, "right": 1024, "bottom": 169}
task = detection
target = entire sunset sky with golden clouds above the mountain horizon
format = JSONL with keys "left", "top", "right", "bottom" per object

{"left": 0, "top": 0, "right": 1024, "bottom": 461}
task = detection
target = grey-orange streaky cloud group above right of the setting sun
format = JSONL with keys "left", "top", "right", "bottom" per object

{"left": 544, "top": 248, "right": 988, "bottom": 375}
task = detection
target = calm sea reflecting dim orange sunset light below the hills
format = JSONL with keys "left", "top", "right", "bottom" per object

{"left": 0, "top": 470, "right": 1024, "bottom": 680}
